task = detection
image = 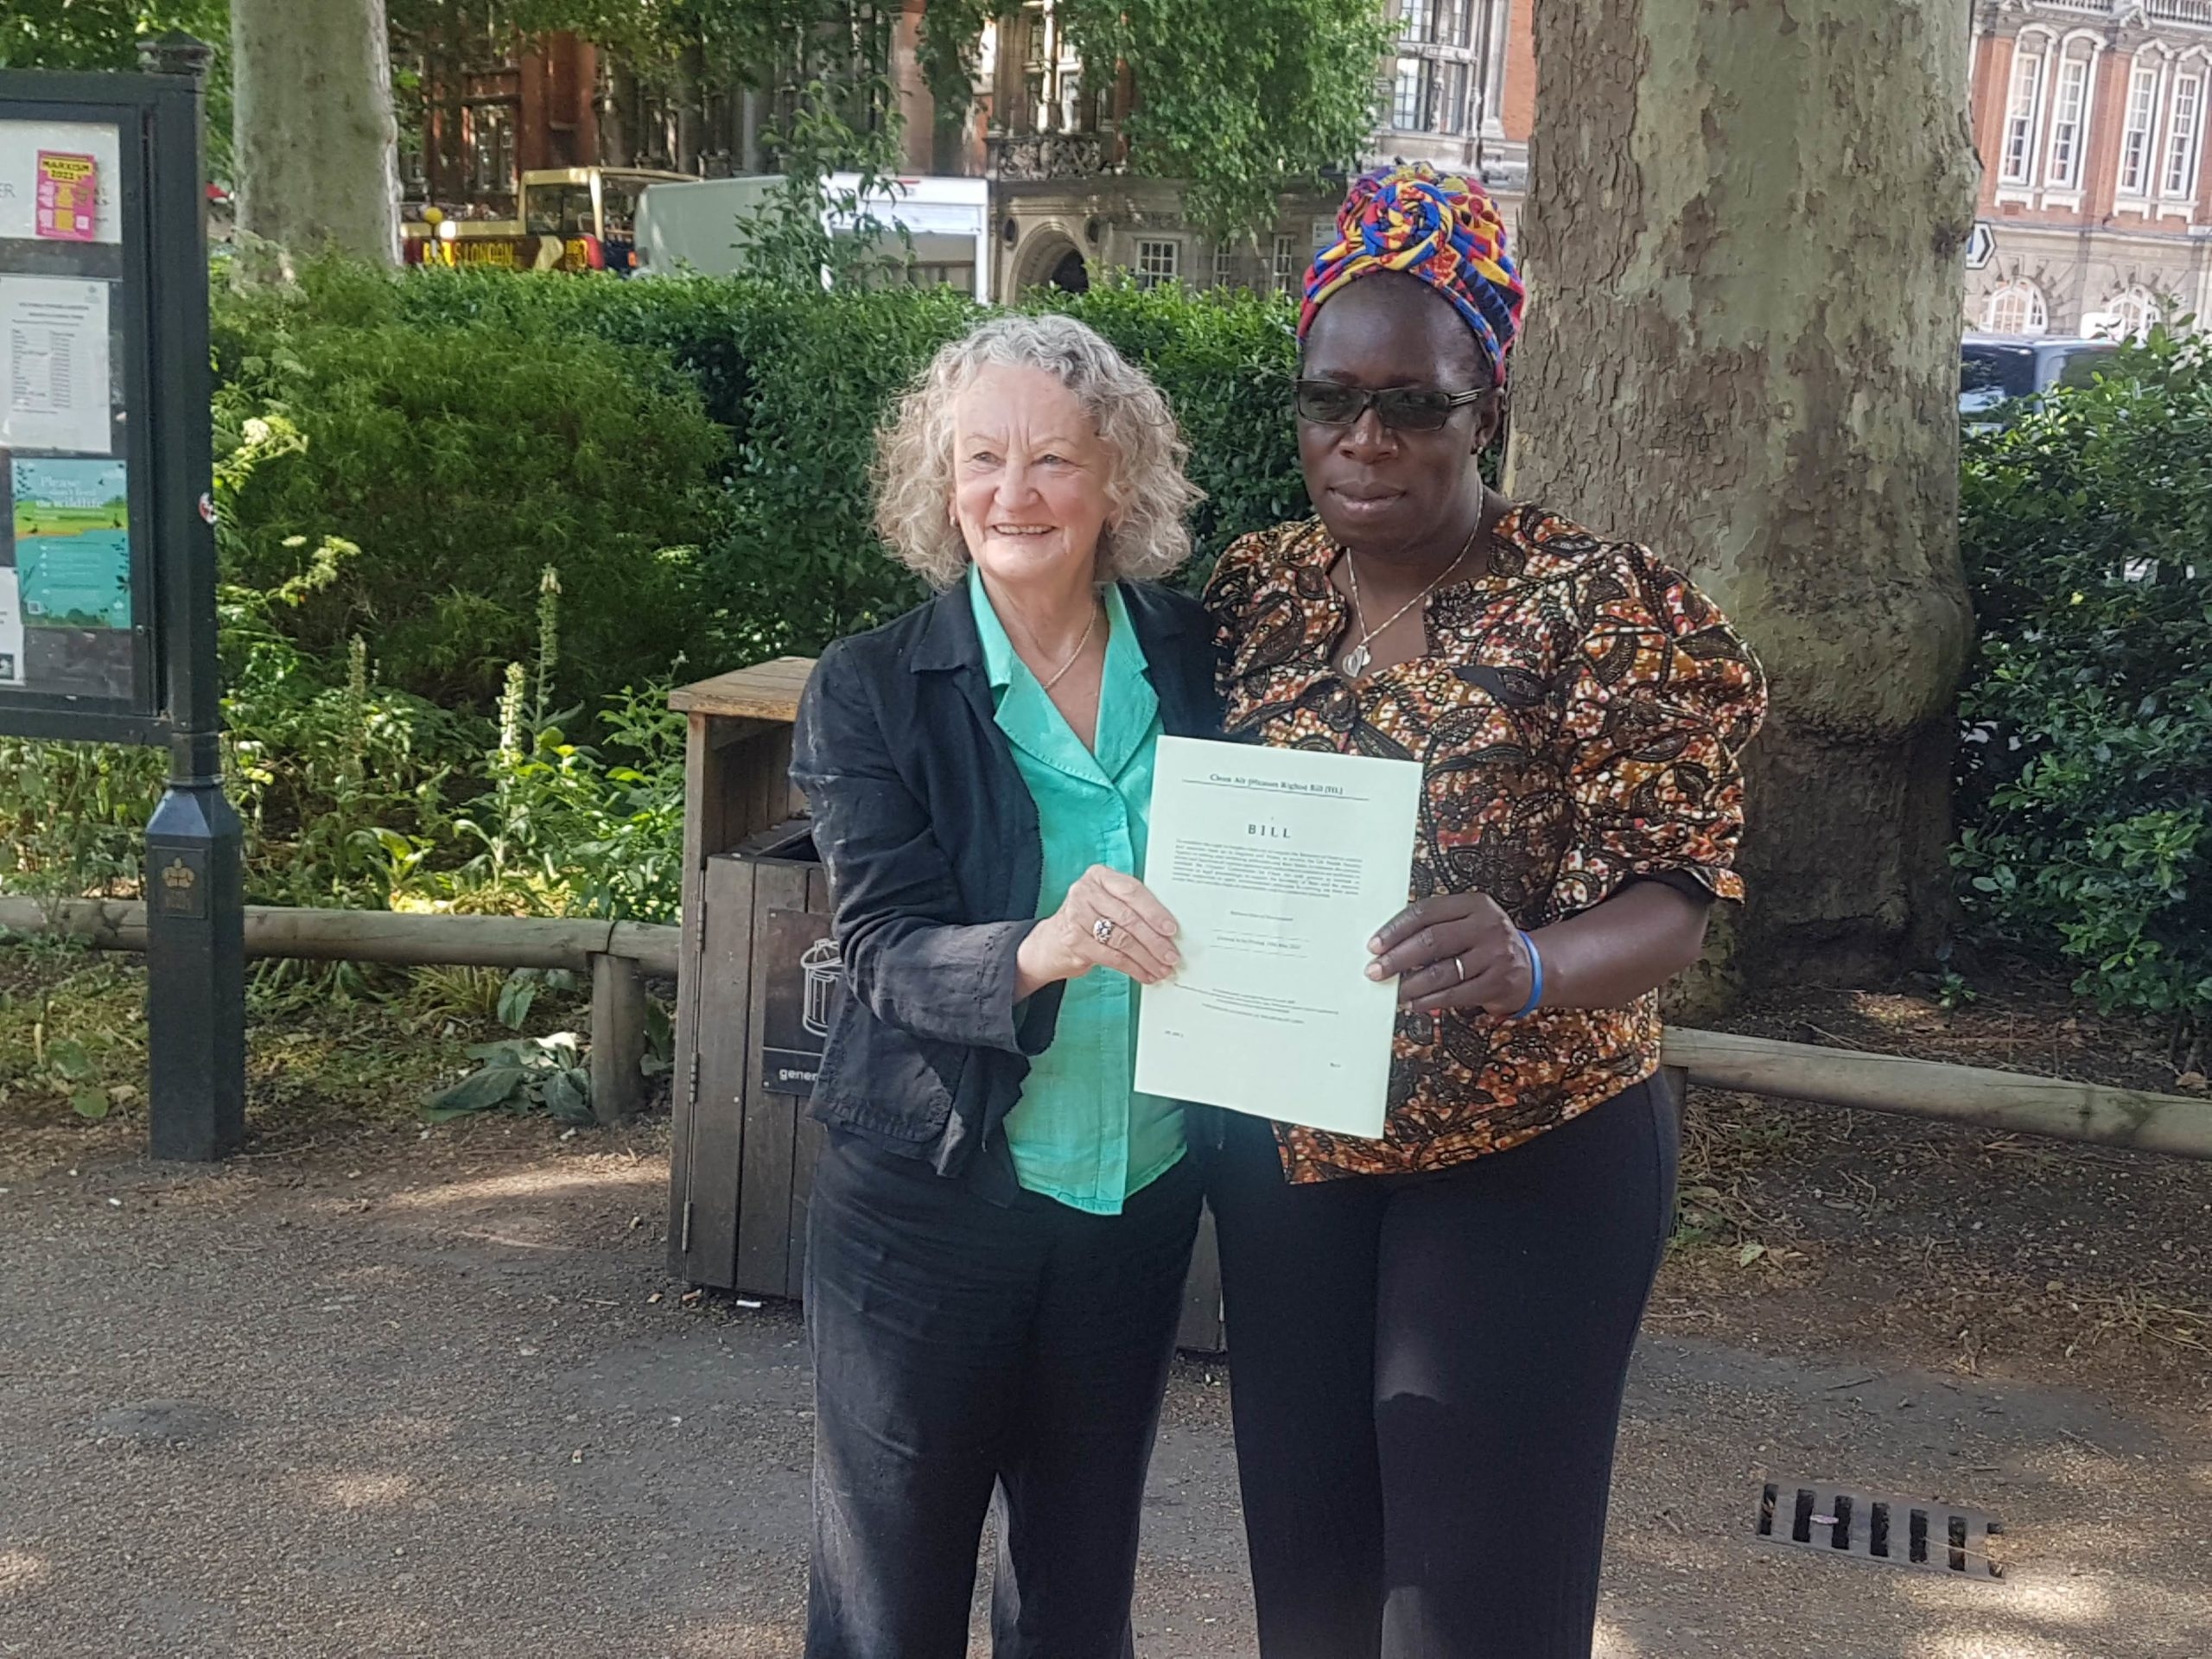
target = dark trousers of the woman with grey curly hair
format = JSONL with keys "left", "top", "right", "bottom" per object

{"left": 805, "top": 1137, "right": 1204, "bottom": 1659}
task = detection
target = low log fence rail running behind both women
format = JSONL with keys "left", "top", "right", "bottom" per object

{"left": 0, "top": 898, "right": 2212, "bottom": 1159}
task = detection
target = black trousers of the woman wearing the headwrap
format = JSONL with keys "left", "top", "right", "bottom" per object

{"left": 1212, "top": 1079, "right": 1681, "bottom": 1659}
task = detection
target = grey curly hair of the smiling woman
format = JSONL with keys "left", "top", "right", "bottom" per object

{"left": 876, "top": 316, "right": 1205, "bottom": 588}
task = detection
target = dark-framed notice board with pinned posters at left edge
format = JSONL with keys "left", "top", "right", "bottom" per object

{"left": 0, "top": 75, "right": 213, "bottom": 741}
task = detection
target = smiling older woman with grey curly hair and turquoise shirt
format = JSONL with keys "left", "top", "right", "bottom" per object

{"left": 791, "top": 316, "right": 1221, "bottom": 1659}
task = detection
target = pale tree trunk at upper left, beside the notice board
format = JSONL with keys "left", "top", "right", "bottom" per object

{"left": 230, "top": 0, "right": 400, "bottom": 279}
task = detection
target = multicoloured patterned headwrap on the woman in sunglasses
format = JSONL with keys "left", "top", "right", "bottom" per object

{"left": 1299, "top": 162, "right": 1529, "bottom": 385}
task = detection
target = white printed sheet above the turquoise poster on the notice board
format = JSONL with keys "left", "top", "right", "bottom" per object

{"left": 0, "top": 276, "right": 113, "bottom": 455}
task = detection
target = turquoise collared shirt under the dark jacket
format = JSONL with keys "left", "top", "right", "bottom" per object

{"left": 969, "top": 570, "right": 1184, "bottom": 1214}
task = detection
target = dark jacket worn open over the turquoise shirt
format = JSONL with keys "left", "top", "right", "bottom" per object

{"left": 791, "top": 584, "right": 1221, "bottom": 1174}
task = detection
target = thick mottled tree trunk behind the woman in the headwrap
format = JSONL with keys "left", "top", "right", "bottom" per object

{"left": 1506, "top": 0, "right": 1978, "bottom": 988}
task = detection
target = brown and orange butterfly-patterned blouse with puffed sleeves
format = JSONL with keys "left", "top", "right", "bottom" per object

{"left": 1205, "top": 506, "right": 1767, "bottom": 1181}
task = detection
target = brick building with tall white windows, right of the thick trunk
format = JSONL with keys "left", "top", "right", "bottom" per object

{"left": 1967, "top": 0, "right": 2212, "bottom": 334}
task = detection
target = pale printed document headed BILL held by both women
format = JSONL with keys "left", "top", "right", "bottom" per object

{"left": 1137, "top": 736, "right": 1421, "bottom": 1139}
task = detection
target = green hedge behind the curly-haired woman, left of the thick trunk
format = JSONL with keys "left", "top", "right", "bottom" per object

{"left": 217, "top": 265, "right": 1305, "bottom": 706}
